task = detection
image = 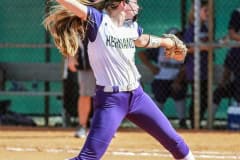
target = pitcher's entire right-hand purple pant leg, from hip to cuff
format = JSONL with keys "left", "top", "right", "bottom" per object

{"left": 127, "top": 90, "right": 189, "bottom": 159}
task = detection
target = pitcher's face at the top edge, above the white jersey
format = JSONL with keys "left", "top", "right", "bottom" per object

{"left": 125, "top": 0, "right": 139, "bottom": 19}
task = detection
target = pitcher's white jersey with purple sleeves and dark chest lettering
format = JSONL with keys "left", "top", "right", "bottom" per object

{"left": 87, "top": 7, "right": 142, "bottom": 86}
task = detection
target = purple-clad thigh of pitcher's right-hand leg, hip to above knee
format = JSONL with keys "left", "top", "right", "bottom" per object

{"left": 127, "top": 90, "right": 180, "bottom": 144}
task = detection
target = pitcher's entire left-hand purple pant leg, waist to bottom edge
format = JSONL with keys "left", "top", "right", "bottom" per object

{"left": 79, "top": 91, "right": 128, "bottom": 159}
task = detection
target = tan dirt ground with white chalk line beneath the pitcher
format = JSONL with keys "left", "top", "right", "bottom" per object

{"left": 0, "top": 127, "right": 240, "bottom": 160}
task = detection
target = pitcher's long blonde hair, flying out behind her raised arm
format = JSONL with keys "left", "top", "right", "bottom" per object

{"left": 43, "top": 0, "right": 121, "bottom": 57}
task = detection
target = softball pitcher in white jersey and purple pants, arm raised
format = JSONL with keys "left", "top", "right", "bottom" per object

{"left": 45, "top": 0, "right": 194, "bottom": 160}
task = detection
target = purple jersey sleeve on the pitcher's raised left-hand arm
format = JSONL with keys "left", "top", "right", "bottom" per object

{"left": 87, "top": 6, "right": 103, "bottom": 42}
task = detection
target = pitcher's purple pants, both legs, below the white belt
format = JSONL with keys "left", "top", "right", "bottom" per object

{"left": 72, "top": 87, "right": 189, "bottom": 160}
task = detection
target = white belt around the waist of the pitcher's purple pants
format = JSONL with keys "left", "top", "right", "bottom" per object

{"left": 96, "top": 82, "right": 139, "bottom": 93}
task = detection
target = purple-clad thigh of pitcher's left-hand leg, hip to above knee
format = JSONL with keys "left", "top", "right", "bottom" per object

{"left": 89, "top": 91, "right": 129, "bottom": 142}
